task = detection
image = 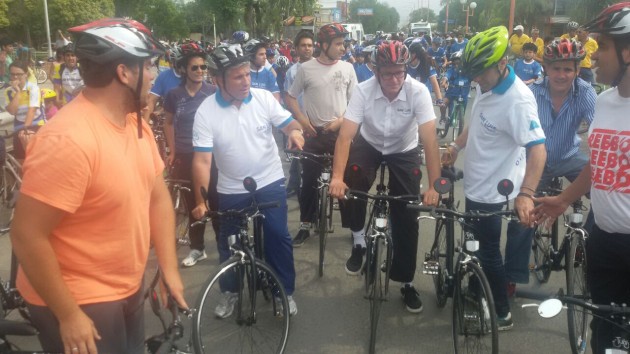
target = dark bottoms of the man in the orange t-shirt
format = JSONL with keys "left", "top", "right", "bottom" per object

{"left": 27, "top": 287, "right": 144, "bottom": 354}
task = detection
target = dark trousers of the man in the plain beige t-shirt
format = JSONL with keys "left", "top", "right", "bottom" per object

{"left": 300, "top": 131, "right": 337, "bottom": 222}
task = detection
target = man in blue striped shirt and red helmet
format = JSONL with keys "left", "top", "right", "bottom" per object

{"left": 505, "top": 39, "right": 597, "bottom": 295}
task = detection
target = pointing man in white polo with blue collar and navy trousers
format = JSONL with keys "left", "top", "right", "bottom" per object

{"left": 193, "top": 44, "right": 304, "bottom": 318}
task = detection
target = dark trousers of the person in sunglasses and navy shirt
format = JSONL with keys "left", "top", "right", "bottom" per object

{"left": 173, "top": 153, "right": 219, "bottom": 251}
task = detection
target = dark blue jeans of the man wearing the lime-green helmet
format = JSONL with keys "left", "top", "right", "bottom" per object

{"left": 466, "top": 198, "right": 516, "bottom": 317}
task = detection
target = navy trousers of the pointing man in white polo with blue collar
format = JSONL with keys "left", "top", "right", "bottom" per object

{"left": 217, "top": 178, "right": 295, "bottom": 295}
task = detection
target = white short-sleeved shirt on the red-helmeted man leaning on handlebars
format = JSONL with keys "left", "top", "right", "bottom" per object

{"left": 344, "top": 75, "right": 435, "bottom": 155}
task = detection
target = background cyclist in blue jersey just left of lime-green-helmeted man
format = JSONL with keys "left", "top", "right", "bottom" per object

{"left": 437, "top": 52, "right": 470, "bottom": 128}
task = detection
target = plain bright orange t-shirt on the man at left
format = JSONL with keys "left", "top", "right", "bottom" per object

{"left": 17, "top": 94, "right": 164, "bottom": 305}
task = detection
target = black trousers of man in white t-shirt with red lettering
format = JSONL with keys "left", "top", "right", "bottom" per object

{"left": 586, "top": 225, "right": 630, "bottom": 354}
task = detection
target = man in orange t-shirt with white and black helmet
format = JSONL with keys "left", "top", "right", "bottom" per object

{"left": 11, "top": 19, "right": 187, "bottom": 354}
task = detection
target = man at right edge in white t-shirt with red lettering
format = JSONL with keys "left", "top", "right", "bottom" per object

{"left": 535, "top": 2, "right": 630, "bottom": 354}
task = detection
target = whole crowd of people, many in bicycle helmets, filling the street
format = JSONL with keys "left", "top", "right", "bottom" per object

{"left": 0, "top": 2, "right": 630, "bottom": 354}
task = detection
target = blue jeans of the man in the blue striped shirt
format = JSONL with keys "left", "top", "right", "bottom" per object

{"left": 505, "top": 152, "right": 593, "bottom": 284}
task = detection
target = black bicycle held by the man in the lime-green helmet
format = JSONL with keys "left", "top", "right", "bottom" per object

{"left": 407, "top": 177, "right": 514, "bottom": 354}
